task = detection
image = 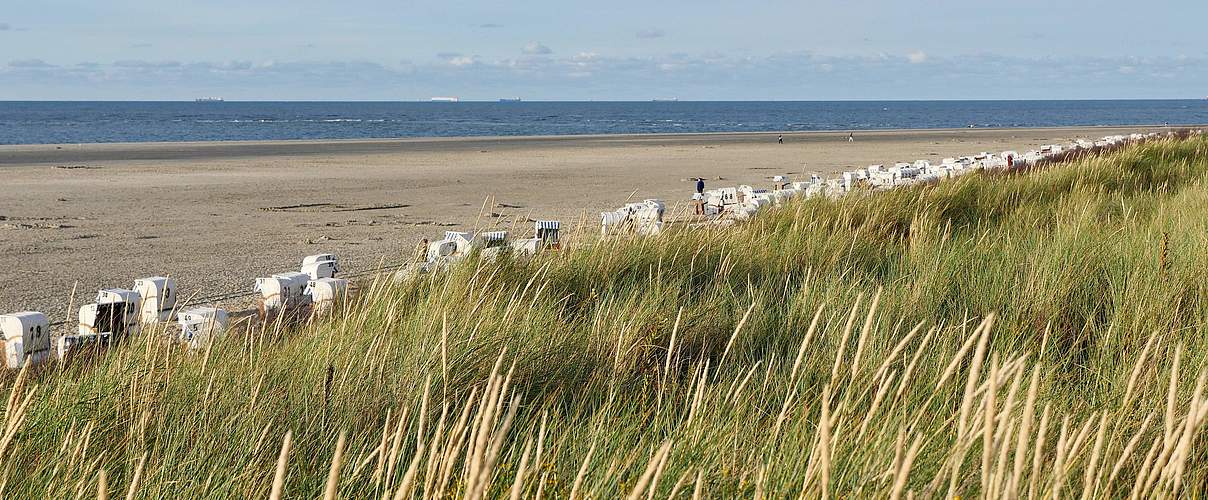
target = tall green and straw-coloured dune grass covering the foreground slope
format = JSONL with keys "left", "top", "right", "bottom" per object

{"left": 0, "top": 132, "right": 1208, "bottom": 499}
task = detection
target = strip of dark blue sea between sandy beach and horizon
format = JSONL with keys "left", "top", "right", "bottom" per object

{"left": 0, "top": 100, "right": 1208, "bottom": 144}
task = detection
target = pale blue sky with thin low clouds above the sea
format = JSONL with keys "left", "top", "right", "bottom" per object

{"left": 0, "top": 0, "right": 1208, "bottom": 100}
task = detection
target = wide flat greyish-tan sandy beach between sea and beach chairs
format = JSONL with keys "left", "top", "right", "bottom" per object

{"left": 0, "top": 127, "right": 1160, "bottom": 325}
